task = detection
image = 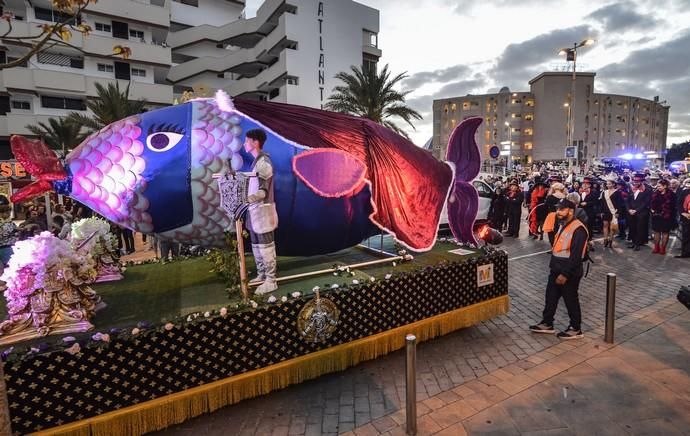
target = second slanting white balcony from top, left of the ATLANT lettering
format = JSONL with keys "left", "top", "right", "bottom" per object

{"left": 168, "top": 14, "right": 295, "bottom": 83}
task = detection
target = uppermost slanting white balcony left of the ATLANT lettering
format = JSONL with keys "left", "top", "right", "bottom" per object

{"left": 167, "top": 0, "right": 295, "bottom": 48}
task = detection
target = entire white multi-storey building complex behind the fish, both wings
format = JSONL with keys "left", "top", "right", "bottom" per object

{"left": 0, "top": 0, "right": 381, "bottom": 159}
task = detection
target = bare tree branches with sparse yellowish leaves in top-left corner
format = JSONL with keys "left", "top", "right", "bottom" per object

{"left": 0, "top": 0, "right": 132, "bottom": 70}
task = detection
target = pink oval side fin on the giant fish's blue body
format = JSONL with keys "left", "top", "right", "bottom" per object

{"left": 292, "top": 148, "right": 366, "bottom": 198}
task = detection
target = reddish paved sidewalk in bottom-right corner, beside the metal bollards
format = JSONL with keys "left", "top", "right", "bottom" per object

{"left": 344, "top": 298, "right": 690, "bottom": 436}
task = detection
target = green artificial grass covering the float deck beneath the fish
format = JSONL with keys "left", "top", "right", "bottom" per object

{"left": 0, "top": 236, "right": 479, "bottom": 338}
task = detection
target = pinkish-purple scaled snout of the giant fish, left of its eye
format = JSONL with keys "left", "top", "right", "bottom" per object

{"left": 66, "top": 116, "right": 153, "bottom": 233}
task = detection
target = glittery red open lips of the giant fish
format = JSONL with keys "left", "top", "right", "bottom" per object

{"left": 10, "top": 135, "right": 67, "bottom": 202}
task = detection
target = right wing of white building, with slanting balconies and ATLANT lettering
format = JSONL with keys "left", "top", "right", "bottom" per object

{"left": 167, "top": 0, "right": 381, "bottom": 107}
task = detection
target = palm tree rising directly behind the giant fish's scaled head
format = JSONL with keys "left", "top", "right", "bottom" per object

{"left": 67, "top": 82, "right": 147, "bottom": 132}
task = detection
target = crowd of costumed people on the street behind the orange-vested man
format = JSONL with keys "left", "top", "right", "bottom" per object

{"left": 482, "top": 168, "right": 690, "bottom": 258}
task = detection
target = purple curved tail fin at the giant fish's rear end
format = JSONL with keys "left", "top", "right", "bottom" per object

{"left": 446, "top": 117, "right": 483, "bottom": 244}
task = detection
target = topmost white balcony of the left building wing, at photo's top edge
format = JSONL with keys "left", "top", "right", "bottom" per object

{"left": 86, "top": 0, "right": 170, "bottom": 28}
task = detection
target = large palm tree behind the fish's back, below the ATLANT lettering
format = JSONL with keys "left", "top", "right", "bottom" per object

{"left": 325, "top": 65, "right": 422, "bottom": 139}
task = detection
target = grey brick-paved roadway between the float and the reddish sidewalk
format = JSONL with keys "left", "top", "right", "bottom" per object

{"left": 159, "top": 227, "right": 690, "bottom": 436}
